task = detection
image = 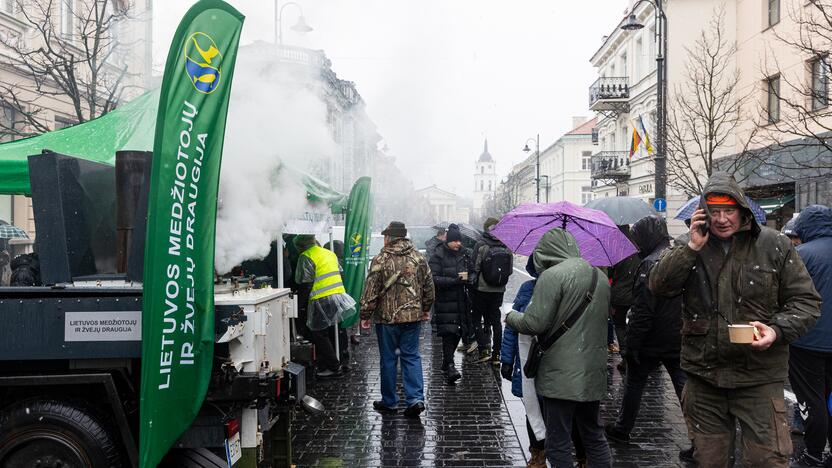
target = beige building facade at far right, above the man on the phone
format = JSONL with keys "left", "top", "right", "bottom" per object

{"left": 667, "top": 0, "right": 832, "bottom": 228}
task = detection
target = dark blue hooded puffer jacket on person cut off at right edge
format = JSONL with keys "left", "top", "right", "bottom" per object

{"left": 792, "top": 205, "right": 832, "bottom": 353}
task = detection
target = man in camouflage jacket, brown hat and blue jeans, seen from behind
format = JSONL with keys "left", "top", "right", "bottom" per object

{"left": 361, "top": 221, "right": 434, "bottom": 418}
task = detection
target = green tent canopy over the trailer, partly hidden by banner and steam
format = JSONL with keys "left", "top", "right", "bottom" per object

{"left": 0, "top": 89, "right": 347, "bottom": 214}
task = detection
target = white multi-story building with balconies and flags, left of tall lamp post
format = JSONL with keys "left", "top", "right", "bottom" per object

{"left": 589, "top": 2, "right": 656, "bottom": 207}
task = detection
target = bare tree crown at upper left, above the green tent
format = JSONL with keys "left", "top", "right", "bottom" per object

{"left": 0, "top": 0, "right": 138, "bottom": 138}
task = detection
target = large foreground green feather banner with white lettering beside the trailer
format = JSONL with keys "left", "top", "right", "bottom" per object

{"left": 139, "top": 0, "right": 243, "bottom": 468}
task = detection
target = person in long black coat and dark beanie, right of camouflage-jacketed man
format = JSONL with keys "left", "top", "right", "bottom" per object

{"left": 430, "top": 224, "right": 473, "bottom": 384}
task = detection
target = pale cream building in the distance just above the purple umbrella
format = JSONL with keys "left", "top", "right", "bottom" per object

{"left": 540, "top": 117, "right": 598, "bottom": 205}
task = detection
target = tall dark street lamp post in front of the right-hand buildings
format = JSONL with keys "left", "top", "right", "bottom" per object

{"left": 621, "top": 0, "right": 667, "bottom": 204}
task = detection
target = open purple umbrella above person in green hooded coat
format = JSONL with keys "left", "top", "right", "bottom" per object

{"left": 491, "top": 201, "right": 636, "bottom": 266}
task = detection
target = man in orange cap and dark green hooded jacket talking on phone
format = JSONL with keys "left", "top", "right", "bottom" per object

{"left": 649, "top": 172, "right": 820, "bottom": 468}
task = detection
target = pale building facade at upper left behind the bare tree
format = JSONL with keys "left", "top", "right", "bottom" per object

{"left": 0, "top": 0, "right": 153, "bottom": 236}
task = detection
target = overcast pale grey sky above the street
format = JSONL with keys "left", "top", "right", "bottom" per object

{"left": 153, "top": 0, "right": 628, "bottom": 195}
